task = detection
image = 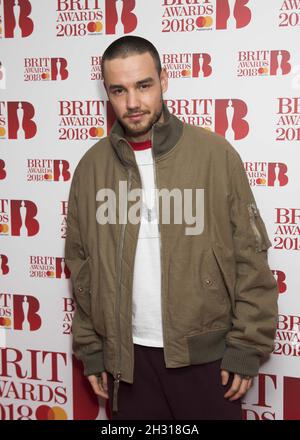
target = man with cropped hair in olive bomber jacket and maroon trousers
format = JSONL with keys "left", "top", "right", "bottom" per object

{"left": 65, "top": 36, "right": 278, "bottom": 419}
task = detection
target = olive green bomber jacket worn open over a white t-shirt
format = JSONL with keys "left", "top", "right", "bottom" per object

{"left": 65, "top": 104, "right": 278, "bottom": 411}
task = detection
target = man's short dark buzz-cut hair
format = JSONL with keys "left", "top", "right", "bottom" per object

{"left": 101, "top": 35, "right": 162, "bottom": 79}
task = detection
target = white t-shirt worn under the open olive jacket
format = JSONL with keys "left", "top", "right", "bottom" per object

{"left": 132, "top": 144, "right": 163, "bottom": 347}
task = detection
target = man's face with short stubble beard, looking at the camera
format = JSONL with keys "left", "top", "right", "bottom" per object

{"left": 104, "top": 52, "right": 168, "bottom": 142}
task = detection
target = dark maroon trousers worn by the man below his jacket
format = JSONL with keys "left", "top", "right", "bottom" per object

{"left": 107, "top": 344, "right": 242, "bottom": 420}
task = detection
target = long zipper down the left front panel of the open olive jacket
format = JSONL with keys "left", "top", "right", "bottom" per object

{"left": 113, "top": 168, "right": 132, "bottom": 411}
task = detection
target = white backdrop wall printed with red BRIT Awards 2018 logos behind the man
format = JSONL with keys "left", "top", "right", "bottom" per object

{"left": 0, "top": 0, "right": 300, "bottom": 420}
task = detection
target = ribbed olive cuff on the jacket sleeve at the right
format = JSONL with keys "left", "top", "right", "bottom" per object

{"left": 221, "top": 347, "right": 260, "bottom": 376}
